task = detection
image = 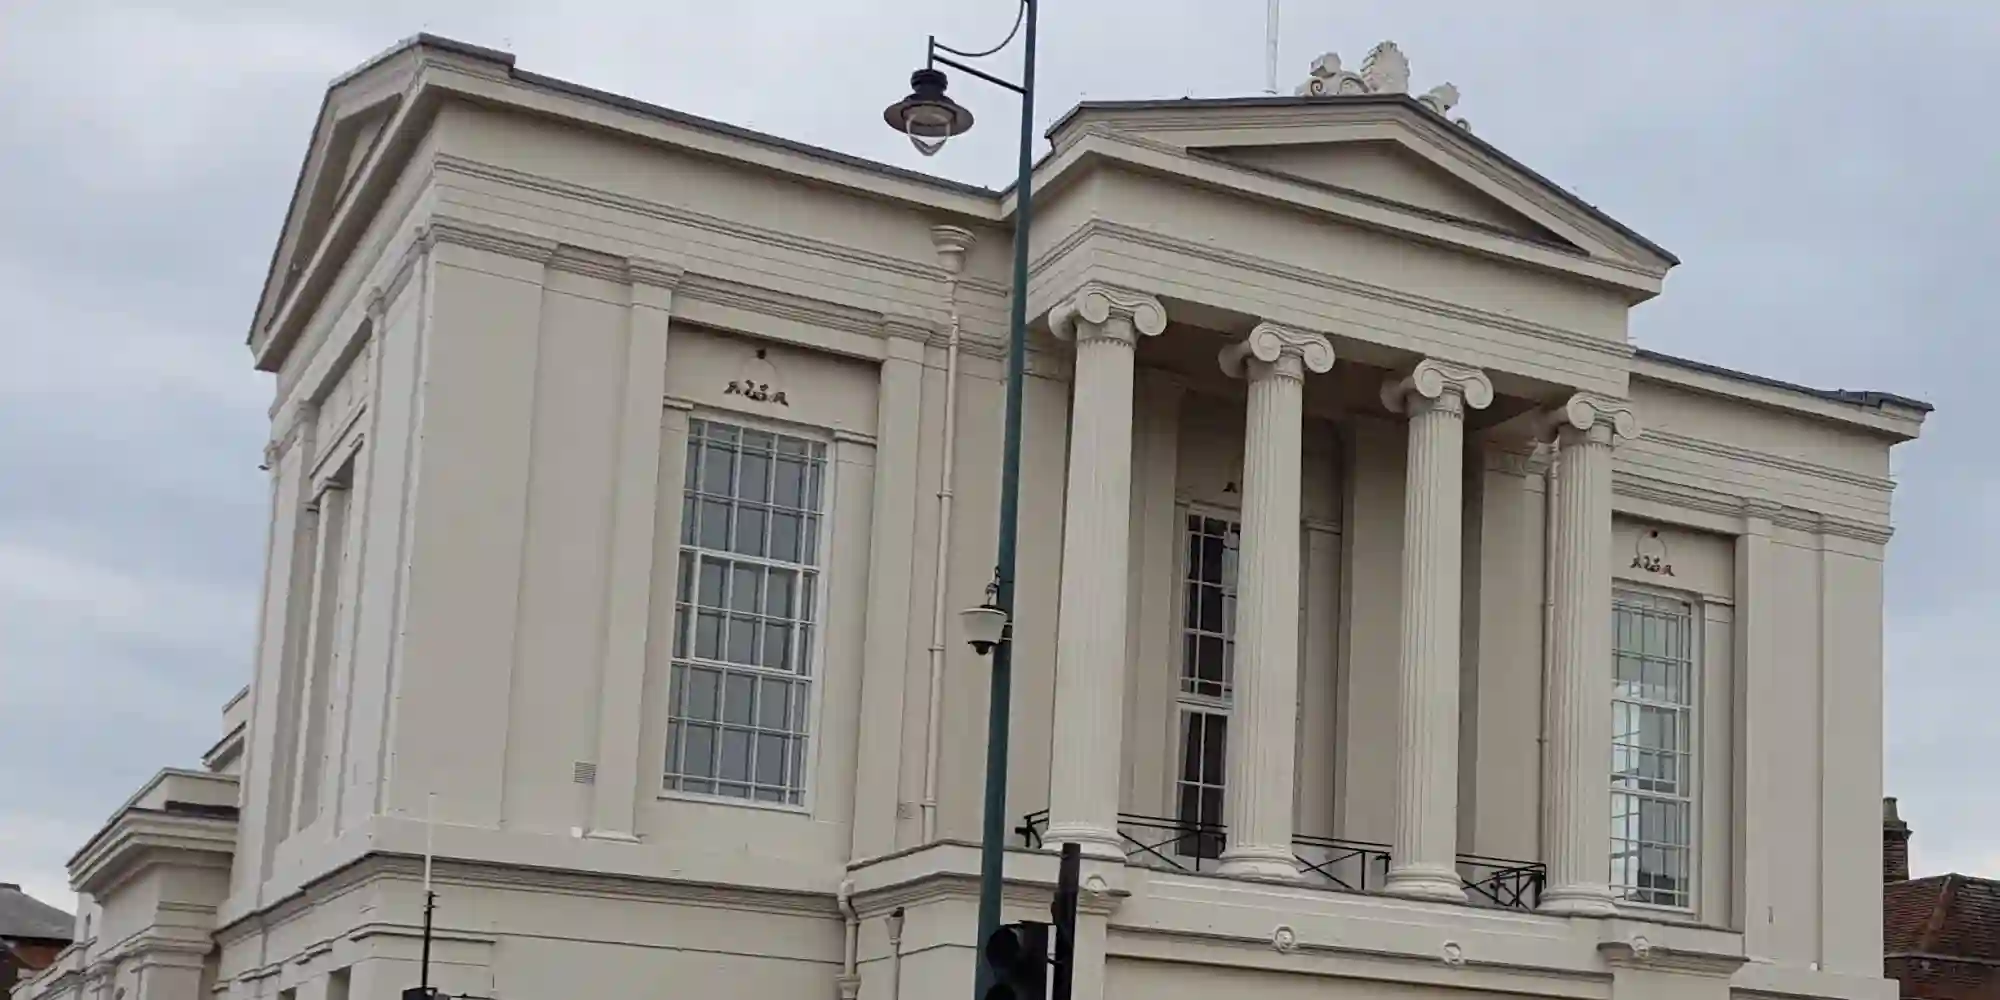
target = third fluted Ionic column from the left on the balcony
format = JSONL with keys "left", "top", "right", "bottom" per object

{"left": 1382, "top": 360, "right": 1494, "bottom": 902}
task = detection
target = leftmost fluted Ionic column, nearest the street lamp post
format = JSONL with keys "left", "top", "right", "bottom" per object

{"left": 1044, "top": 282, "right": 1166, "bottom": 860}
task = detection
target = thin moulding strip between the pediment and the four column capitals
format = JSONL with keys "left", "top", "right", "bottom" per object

{"left": 1030, "top": 218, "right": 1634, "bottom": 366}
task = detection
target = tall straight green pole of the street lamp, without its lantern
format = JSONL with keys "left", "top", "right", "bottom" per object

{"left": 972, "top": 0, "right": 1038, "bottom": 1000}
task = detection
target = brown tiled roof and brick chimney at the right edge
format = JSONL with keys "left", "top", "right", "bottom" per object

{"left": 1882, "top": 798, "right": 2000, "bottom": 1000}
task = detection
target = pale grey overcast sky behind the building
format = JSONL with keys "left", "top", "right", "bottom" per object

{"left": 0, "top": 0, "right": 2000, "bottom": 906}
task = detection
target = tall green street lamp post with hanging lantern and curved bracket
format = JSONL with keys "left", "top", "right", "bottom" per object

{"left": 882, "top": 0, "right": 1038, "bottom": 998}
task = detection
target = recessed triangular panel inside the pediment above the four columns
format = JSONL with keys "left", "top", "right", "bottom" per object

{"left": 1212, "top": 140, "right": 1574, "bottom": 248}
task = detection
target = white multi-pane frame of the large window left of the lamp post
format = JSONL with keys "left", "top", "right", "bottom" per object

{"left": 656, "top": 414, "right": 840, "bottom": 814}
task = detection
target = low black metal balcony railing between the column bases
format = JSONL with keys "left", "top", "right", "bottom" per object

{"left": 1014, "top": 810, "right": 1548, "bottom": 910}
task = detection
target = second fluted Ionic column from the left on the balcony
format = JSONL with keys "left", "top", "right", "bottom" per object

{"left": 1220, "top": 322, "right": 1334, "bottom": 878}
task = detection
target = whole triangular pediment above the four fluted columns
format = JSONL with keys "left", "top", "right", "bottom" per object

{"left": 1050, "top": 94, "right": 1678, "bottom": 278}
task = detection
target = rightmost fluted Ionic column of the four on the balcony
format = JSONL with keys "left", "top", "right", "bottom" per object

{"left": 1542, "top": 392, "right": 1638, "bottom": 914}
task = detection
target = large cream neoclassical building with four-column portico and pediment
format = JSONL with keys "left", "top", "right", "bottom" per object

{"left": 16, "top": 36, "right": 1930, "bottom": 1000}
